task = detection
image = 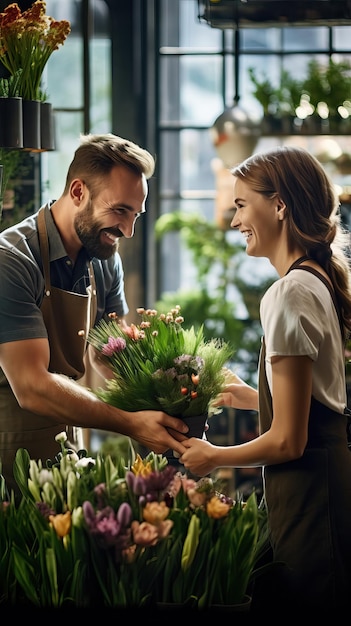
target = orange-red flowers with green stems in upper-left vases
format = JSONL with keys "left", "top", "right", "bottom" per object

{"left": 0, "top": 0, "right": 71, "bottom": 100}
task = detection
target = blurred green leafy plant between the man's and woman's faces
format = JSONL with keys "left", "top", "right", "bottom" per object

{"left": 155, "top": 211, "right": 272, "bottom": 382}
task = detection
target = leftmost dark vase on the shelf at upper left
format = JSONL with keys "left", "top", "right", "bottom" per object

{"left": 0, "top": 97, "right": 23, "bottom": 148}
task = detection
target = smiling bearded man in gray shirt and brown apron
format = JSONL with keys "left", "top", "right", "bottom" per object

{"left": 0, "top": 134, "right": 187, "bottom": 489}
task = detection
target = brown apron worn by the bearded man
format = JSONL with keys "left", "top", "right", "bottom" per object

{"left": 0, "top": 209, "right": 96, "bottom": 490}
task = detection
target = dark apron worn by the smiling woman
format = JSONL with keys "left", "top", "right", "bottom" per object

{"left": 259, "top": 266, "right": 351, "bottom": 611}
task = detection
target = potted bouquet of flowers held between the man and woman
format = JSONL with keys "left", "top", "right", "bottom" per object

{"left": 88, "top": 306, "right": 233, "bottom": 418}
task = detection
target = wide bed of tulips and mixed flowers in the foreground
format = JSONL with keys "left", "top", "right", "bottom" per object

{"left": 0, "top": 433, "right": 272, "bottom": 609}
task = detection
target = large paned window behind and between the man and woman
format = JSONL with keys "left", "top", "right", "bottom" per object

{"left": 158, "top": 0, "right": 351, "bottom": 300}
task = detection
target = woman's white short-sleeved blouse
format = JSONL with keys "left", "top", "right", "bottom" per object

{"left": 260, "top": 269, "right": 346, "bottom": 413}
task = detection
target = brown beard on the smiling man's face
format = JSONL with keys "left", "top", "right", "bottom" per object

{"left": 74, "top": 202, "right": 123, "bottom": 260}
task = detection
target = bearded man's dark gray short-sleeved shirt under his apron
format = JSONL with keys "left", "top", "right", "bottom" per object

{"left": 0, "top": 205, "right": 128, "bottom": 343}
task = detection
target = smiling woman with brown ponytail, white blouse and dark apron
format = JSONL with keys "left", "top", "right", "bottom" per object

{"left": 180, "top": 147, "right": 351, "bottom": 610}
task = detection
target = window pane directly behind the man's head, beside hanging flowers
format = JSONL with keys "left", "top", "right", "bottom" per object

{"left": 41, "top": 0, "right": 112, "bottom": 202}
